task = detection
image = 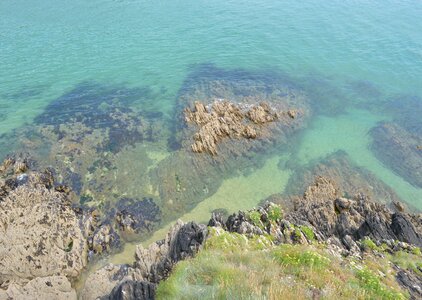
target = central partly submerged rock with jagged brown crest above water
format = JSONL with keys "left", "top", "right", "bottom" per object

{"left": 150, "top": 67, "right": 310, "bottom": 222}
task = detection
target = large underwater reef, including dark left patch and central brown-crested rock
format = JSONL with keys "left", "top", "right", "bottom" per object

{"left": 0, "top": 65, "right": 310, "bottom": 240}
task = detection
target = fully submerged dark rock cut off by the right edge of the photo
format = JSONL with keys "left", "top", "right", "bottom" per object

{"left": 371, "top": 122, "right": 422, "bottom": 188}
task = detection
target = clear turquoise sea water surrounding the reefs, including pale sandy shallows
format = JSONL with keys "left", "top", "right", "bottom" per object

{"left": 0, "top": 0, "right": 422, "bottom": 244}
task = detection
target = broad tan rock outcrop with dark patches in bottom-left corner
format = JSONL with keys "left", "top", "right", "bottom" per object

{"left": 0, "top": 157, "right": 116, "bottom": 299}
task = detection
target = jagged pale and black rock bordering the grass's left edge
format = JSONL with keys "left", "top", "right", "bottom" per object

{"left": 81, "top": 220, "right": 207, "bottom": 300}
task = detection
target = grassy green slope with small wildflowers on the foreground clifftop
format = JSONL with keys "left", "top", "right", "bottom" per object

{"left": 157, "top": 228, "right": 412, "bottom": 300}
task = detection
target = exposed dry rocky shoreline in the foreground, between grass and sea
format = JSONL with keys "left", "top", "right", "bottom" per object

{"left": 0, "top": 156, "right": 422, "bottom": 299}
